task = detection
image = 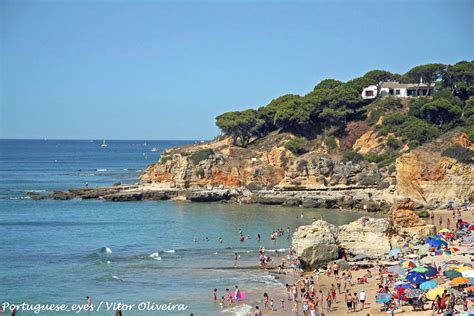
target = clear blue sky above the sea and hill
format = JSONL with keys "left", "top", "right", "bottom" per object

{"left": 0, "top": 0, "right": 474, "bottom": 139}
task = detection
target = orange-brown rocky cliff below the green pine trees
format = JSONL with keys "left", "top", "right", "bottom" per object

{"left": 136, "top": 126, "right": 474, "bottom": 210}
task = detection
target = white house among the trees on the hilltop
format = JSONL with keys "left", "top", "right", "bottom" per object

{"left": 362, "top": 80, "right": 434, "bottom": 100}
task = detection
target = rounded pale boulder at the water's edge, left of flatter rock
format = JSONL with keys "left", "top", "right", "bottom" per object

{"left": 293, "top": 220, "right": 338, "bottom": 267}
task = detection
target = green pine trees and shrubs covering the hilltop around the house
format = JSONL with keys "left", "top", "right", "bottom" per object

{"left": 216, "top": 61, "right": 474, "bottom": 154}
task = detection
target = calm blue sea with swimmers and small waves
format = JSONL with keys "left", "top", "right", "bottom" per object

{"left": 0, "top": 139, "right": 378, "bottom": 315}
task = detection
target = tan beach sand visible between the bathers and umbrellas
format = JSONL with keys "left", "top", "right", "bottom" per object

{"left": 231, "top": 209, "right": 474, "bottom": 316}
